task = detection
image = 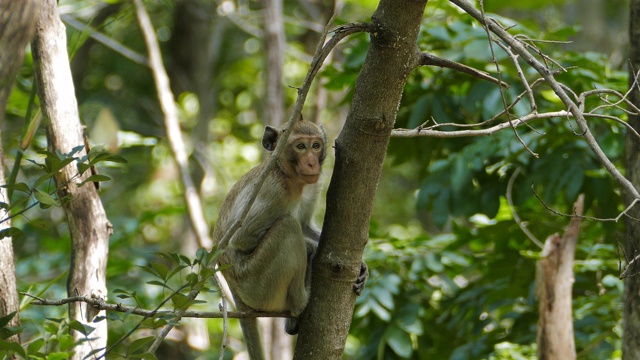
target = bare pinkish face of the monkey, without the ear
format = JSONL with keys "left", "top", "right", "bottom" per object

{"left": 290, "top": 136, "right": 324, "bottom": 184}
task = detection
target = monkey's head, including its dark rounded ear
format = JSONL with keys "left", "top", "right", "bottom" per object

{"left": 262, "top": 120, "right": 327, "bottom": 184}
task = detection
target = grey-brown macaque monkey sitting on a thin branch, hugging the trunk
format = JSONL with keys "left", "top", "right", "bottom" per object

{"left": 213, "top": 119, "right": 366, "bottom": 360}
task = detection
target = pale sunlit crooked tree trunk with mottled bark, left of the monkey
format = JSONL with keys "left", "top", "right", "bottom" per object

{"left": 32, "top": 0, "right": 111, "bottom": 359}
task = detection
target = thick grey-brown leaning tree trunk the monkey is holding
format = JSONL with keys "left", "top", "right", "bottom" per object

{"left": 294, "top": 0, "right": 427, "bottom": 359}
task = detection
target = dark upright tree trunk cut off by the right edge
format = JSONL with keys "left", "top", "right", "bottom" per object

{"left": 622, "top": 0, "right": 640, "bottom": 360}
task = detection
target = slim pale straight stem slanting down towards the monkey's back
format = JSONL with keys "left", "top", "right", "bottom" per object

{"left": 133, "top": 0, "right": 213, "bottom": 249}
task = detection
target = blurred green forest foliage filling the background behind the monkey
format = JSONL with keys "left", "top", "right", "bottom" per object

{"left": 0, "top": 0, "right": 627, "bottom": 360}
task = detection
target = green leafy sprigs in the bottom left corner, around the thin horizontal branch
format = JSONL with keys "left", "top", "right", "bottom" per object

{"left": 0, "top": 249, "right": 220, "bottom": 359}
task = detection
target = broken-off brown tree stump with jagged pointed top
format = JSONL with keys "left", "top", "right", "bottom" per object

{"left": 536, "top": 195, "right": 584, "bottom": 360}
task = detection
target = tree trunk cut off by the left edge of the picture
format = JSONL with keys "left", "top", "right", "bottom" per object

{"left": 0, "top": 0, "right": 40, "bottom": 341}
